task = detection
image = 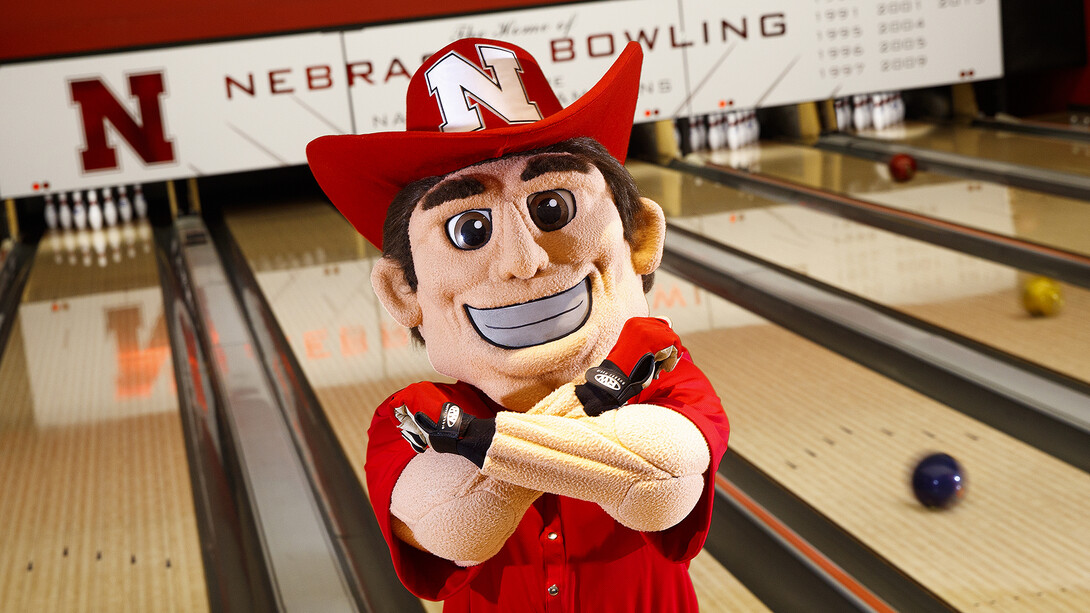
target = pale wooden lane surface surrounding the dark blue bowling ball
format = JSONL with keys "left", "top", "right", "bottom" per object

{"left": 682, "top": 311, "right": 1090, "bottom": 612}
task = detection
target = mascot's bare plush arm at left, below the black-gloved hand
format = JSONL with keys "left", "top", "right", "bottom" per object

{"left": 390, "top": 449, "right": 541, "bottom": 566}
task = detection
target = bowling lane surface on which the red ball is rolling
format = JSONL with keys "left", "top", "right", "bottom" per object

{"left": 687, "top": 142, "right": 1090, "bottom": 254}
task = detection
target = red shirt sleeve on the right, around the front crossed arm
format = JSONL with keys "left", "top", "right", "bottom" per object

{"left": 632, "top": 349, "right": 730, "bottom": 562}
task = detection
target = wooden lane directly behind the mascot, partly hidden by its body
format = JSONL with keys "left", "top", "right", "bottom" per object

{"left": 227, "top": 201, "right": 767, "bottom": 612}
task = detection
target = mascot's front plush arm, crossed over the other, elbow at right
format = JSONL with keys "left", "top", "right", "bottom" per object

{"left": 481, "top": 397, "right": 711, "bottom": 531}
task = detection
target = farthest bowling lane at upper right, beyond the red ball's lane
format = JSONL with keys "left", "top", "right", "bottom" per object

{"left": 845, "top": 121, "right": 1090, "bottom": 177}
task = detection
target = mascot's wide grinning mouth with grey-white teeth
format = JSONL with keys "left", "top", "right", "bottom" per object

{"left": 465, "top": 277, "right": 591, "bottom": 349}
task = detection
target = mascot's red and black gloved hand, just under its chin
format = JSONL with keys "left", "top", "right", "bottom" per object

{"left": 576, "top": 317, "right": 680, "bottom": 417}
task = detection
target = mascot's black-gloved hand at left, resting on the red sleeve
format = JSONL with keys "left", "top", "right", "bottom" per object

{"left": 395, "top": 402, "right": 496, "bottom": 468}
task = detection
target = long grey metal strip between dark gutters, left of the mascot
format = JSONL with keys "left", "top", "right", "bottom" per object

{"left": 175, "top": 217, "right": 362, "bottom": 612}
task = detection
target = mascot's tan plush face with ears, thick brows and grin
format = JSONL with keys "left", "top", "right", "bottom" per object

{"left": 374, "top": 153, "right": 665, "bottom": 410}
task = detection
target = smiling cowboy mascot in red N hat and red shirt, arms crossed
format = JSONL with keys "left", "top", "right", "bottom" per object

{"left": 307, "top": 39, "right": 728, "bottom": 613}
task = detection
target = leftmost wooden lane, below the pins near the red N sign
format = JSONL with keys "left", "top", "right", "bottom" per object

{"left": 0, "top": 230, "right": 208, "bottom": 612}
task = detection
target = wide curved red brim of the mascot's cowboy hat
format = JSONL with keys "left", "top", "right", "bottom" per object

{"left": 306, "top": 43, "right": 643, "bottom": 249}
